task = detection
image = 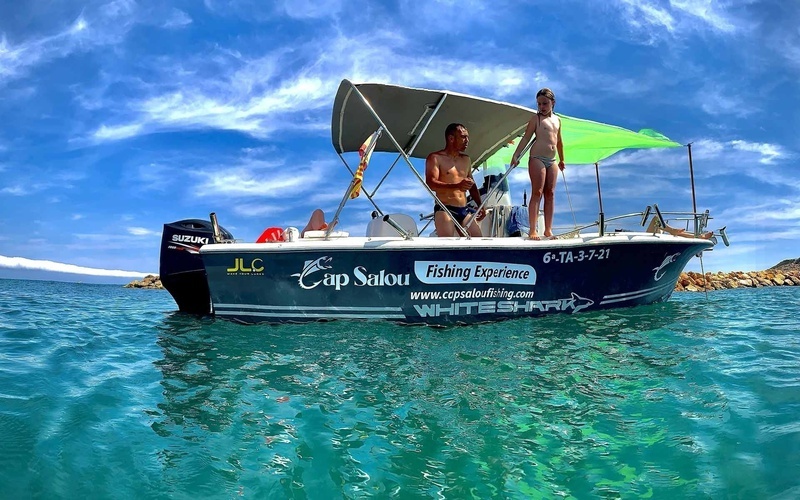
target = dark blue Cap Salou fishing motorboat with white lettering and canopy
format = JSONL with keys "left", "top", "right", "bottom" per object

{"left": 160, "top": 80, "right": 727, "bottom": 325}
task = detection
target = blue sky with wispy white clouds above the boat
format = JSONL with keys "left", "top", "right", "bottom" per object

{"left": 0, "top": 0, "right": 800, "bottom": 281}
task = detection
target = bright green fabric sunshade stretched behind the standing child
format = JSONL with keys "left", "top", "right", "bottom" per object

{"left": 486, "top": 115, "right": 681, "bottom": 168}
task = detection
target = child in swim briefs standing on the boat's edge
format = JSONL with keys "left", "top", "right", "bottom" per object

{"left": 511, "top": 88, "right": 565, "bottom": 240}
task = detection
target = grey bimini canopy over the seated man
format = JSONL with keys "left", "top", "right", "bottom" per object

{"left": 331, "top": 80, "right": 536, "bottom": 164}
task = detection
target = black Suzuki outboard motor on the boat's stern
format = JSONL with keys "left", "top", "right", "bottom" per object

{"left": 159, "top": 219, "right": 233, "bottom": 314}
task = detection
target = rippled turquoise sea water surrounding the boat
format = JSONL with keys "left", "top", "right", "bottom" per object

{"left": 0, "top": 280, "right": 800, "bottom": 499}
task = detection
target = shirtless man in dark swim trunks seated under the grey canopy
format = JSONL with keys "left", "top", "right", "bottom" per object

{"left": 425, "top": 123, "right": 484, "bottom": 236}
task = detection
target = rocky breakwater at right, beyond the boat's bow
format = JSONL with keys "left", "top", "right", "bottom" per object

{"left": 675, "top": 259, "right": 800, "bottom": 292}
